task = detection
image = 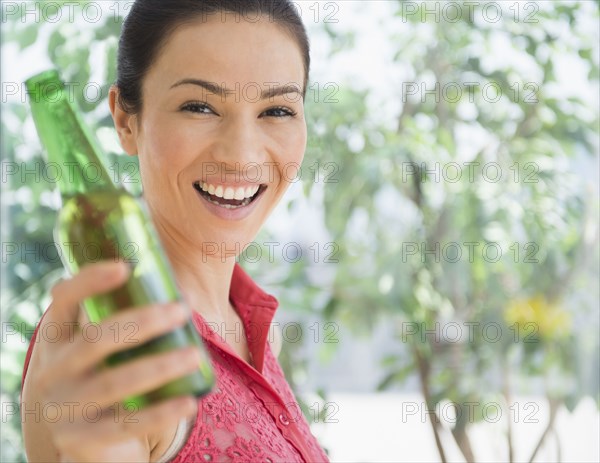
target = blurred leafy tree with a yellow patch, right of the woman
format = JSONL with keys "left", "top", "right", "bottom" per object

{"left": 300, "top": 2, "right": 599, "bottom": 461}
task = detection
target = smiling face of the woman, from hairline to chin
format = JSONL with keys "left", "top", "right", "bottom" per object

{"left": 125, "top": 14, "right": 306, "bottom": 258}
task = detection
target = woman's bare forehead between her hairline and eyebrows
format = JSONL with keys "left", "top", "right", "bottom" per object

{"left": 145, "top": 14, "right": 304, "bottom": 90}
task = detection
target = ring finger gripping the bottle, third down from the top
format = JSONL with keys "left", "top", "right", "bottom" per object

{"left": 70, "top": 347, "right": 201, "bottom": 408}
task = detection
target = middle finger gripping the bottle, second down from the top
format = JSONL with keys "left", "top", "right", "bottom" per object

{"left": 43, "top": 303, "right": 189, "bottom": 384}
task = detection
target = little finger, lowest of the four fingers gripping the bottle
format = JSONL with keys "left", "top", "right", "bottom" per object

{"left": 55, "top": 396, "right": 198, "bottom": 448}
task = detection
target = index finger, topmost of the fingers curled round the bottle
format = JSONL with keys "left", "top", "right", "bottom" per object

{"left": 44, "top": 261, "right": 129, "bottom": 341}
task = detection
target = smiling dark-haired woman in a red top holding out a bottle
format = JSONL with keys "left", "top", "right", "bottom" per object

{"left": 22, "top": 0, "right": 327, "bottom": 463}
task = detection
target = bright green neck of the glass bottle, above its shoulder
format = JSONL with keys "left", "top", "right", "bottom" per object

{"left": 26, "top": 71, "right": 116, "bottom": 198}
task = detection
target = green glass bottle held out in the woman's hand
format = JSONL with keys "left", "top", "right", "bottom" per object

{"left": 26, "top": 70, "right": 215, "bottom": 409}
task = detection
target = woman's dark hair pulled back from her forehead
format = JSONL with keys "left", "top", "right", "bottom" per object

{"left": 116, "top": 0, "right": 310, "bottom": 114}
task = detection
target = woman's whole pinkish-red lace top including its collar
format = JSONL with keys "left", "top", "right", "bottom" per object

{"left": 22, "top": 264, "right": 329, "bottom": 463}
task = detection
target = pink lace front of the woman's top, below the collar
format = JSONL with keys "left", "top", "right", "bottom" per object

{"left": 166, "top": 311, "right": 328, "bottom": 463}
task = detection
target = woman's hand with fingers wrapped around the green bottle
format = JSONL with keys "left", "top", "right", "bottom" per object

{"left": 21, "top": 262, "right": 200, "bottom": 463}
